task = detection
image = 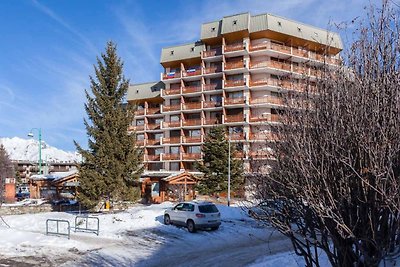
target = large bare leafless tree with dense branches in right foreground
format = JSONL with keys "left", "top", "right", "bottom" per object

{"left": 253, "top": 1, "right": 400, "bottom": 266}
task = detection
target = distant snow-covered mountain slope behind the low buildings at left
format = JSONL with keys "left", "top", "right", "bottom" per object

{"left": 0, "top": 137, "right": 81, "bottom": 162}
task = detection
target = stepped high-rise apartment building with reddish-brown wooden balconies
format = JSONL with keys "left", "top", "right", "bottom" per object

{"left": 128, "top": 13, "right": 342, "bottom": 178}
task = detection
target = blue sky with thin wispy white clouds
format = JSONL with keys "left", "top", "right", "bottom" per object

{"left": 0, "top": 0, "right": 380, "bottom": 151}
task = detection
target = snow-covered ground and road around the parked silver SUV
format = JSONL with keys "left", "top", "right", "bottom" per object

{"left": 0, "top": 203, "right": 310, "bottom": 267}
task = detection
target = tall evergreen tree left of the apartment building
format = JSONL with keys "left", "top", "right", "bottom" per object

{"left": 75, "top": 42, "right": 143, "bottom": 208}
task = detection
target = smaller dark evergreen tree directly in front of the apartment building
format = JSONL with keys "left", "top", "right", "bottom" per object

{"left": 196, "top": 126, "right": 243, "bottom": 194}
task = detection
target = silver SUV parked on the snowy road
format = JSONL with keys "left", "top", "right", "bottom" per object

{"left": 164, "top": 201, "right": 221, "bottom": 233}
